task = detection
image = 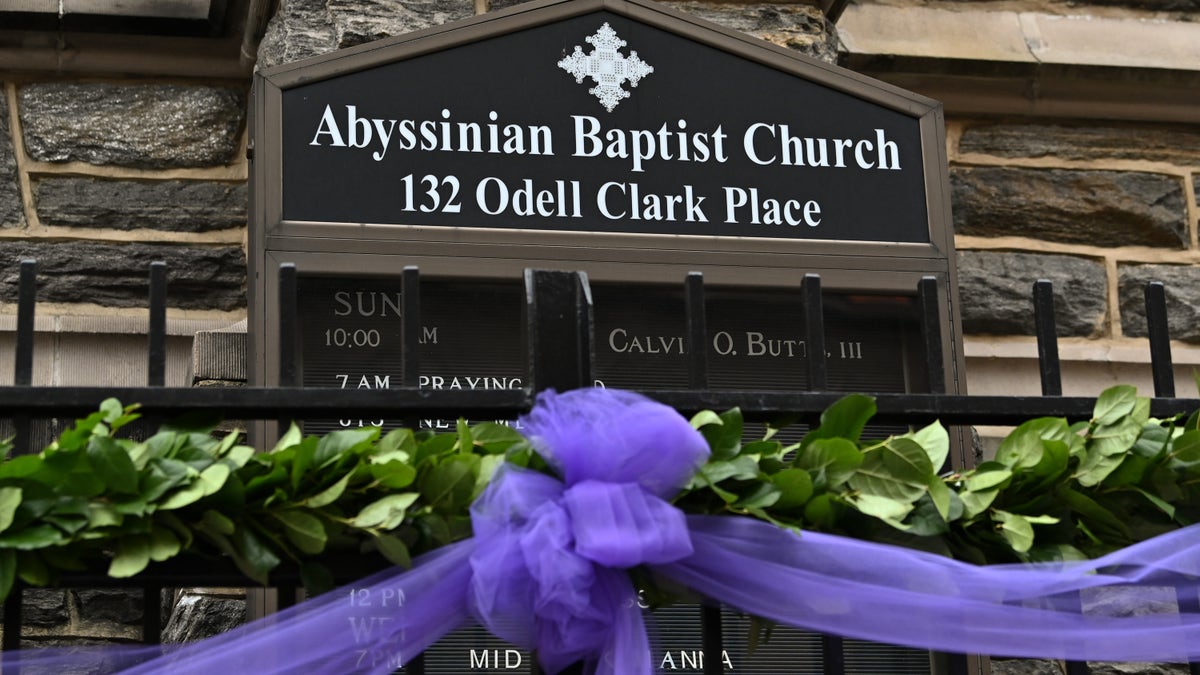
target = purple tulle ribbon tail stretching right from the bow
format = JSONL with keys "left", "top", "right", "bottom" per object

{"left": 654, "top": 516, "right": 1200, "bottom": 662}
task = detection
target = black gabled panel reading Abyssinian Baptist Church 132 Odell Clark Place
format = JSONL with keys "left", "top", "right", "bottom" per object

{"left": 282, "top": 11, "right": 929, "bottom": 243}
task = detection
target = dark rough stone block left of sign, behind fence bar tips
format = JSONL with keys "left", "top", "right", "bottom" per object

{"left": 0, "top": 239, "right": 246, "bottom": 310}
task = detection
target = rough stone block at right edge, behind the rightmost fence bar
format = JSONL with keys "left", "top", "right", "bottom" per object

{"left": 1117, "top": 264, "right": 1200, "bottom": 342}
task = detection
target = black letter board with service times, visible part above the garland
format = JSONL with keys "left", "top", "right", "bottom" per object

{"left": 300, "top": 276, "right": 928, "bottom": 431}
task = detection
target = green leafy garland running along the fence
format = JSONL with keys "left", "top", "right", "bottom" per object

{"left": 0, "top": 387, "right": 1200, "bottom": 598}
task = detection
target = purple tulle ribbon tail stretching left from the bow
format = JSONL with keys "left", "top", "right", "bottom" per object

{"left": 2, "top": 539, "right": 474, "bottom": 675}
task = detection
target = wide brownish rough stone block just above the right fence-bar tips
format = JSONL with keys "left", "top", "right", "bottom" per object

{"left": 950, "top": 167, "right": 1188, "bottom": 249}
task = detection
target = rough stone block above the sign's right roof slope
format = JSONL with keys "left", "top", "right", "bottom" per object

{"left": 666, "top": 1, "right": 838, "bottom": 64}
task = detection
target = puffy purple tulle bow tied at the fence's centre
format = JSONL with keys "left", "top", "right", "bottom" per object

{"left": 470, "top": 389, "right": 708, "bottom": 675}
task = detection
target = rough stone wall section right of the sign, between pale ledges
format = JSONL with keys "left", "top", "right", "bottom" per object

{"left": 947, "top": 119, "right": 1200, "bottom": 344}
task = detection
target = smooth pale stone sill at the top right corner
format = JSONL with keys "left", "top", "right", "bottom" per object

{"left": 838, "top": 4, "right": 1200, "bottom": 123}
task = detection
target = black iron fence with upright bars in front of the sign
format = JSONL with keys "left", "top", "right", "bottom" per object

{"left": 0, "top": 261, "right": 1200, "bottom": 675}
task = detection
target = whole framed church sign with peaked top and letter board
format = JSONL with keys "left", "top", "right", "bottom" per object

{"left": 247, "top": 0, "right": 962, "bottom": 674}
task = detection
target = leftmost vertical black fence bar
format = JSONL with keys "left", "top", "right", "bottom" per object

{"left": 0, "top": 259, "right": 37, "bottom": 663}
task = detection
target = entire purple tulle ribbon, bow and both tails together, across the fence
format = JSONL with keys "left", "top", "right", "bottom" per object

{"left": 5, "top": 389, "right": 1200, "bottom": 675}
